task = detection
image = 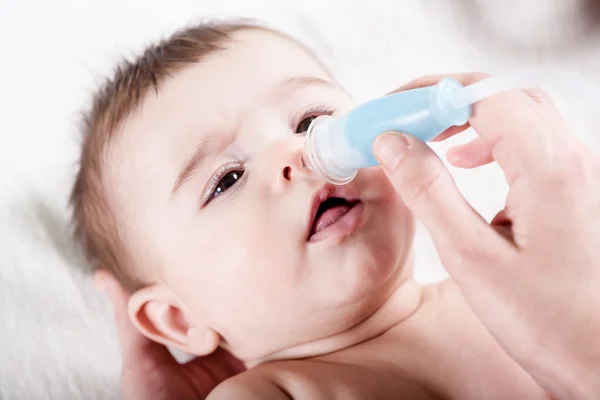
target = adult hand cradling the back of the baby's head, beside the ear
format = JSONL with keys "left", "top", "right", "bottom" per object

{"left": 94, "top": 270, "right": 245, "bottom": 400}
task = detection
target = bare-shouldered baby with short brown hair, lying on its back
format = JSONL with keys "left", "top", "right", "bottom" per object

{"left": 72, "top": 23, "right": 546, "bottom": 400}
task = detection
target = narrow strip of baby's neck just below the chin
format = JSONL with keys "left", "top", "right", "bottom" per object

{"left": 246, "top": 279, "right": 423, "bottom": 367}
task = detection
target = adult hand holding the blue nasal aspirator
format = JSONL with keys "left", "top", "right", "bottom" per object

{"left": 374, "top": 74, "right": 600, "bottom": 399}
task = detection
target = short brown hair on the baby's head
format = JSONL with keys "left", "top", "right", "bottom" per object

{"left": 70, "top": 21, "right": 269, "bottom": 290}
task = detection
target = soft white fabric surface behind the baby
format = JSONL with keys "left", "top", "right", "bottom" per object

{"left": 0, "top": 0, "right": 600, "bottom": 400}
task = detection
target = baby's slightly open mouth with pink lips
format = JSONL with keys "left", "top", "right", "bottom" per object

{"left": 308, "top": 190, "right": 360, "bottom": 240}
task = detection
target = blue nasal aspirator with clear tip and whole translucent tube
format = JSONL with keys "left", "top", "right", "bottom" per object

{"left": 304, "top": 67, "right": 597, "bottom": 185}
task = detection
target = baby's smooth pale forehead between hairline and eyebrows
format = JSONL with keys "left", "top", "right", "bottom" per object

{"left": 117, "top": 30, "right": 332, "bottom": 145}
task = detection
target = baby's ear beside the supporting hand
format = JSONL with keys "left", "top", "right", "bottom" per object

{"left": 128, "top": 284, "right": 220, "bottom": 356}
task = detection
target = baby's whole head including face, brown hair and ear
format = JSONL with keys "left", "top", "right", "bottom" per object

{"left": 72, "top": 19, "right": 413, "bottom": 360}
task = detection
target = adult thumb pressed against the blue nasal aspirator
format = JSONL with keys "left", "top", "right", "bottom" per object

{"left": 373, "top": 133, "right": 506, "bottom": 273}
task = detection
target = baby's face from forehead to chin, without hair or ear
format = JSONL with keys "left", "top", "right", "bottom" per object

{"left": 109, "top": 30, "right": 413, "bottom": 358}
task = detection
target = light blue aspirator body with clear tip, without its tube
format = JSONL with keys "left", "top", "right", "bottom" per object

{"left": 305, "top": 78, "right": 471, "bottom": 184}
